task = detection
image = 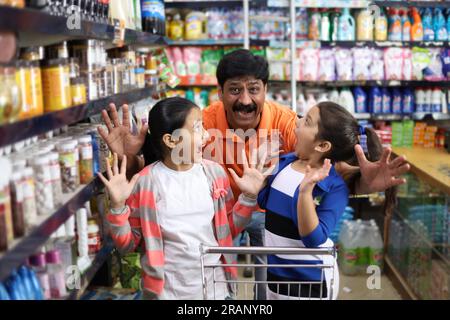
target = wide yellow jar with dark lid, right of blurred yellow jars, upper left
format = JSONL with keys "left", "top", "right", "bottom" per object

{"left": 42, "top": 59, "right": 72, "bottom": 112}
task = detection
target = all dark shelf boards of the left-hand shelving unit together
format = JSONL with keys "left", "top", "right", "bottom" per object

{"left": 0, "top": 6, "right": 167, "bottom": 299}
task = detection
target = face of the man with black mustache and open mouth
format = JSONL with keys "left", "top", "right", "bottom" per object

{"left": 219, "top": 76, "right": 267, "bottom": 131}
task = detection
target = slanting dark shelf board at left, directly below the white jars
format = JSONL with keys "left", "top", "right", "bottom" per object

{"left": 0, "top": 178, "right": 101, "bottom": 282}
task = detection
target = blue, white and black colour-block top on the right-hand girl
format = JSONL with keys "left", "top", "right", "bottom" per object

{"left": 258, "top": 153, "right": 348, "bottom": 297}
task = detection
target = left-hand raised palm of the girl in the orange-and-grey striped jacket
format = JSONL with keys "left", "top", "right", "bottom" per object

{"left": 98, "top": 153, "right": 139, "bottom": 209}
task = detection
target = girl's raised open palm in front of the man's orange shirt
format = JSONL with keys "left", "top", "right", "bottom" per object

{"left": 228, "top": 149, "right": 275, "bottom": 198}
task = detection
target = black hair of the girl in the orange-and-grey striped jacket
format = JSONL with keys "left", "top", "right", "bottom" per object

{"left": 142, "top": 97, "right": 198, "bottom": 166}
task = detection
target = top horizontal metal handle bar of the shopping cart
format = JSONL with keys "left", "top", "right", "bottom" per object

{"left": 200, "top": 244, "right": 336, "bottom": 255}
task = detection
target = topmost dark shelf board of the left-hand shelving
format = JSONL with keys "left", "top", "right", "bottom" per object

{"left": 0, "top": 6, "right": 166, "bottom": 47}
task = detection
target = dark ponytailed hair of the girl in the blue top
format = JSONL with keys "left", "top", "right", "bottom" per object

{"left": 317, "top": 101, "right": 397, "bottom": 212}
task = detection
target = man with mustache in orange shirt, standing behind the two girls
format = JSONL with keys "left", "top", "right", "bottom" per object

{"left": 100, "top": 49, "right": 409, "bottom": 299}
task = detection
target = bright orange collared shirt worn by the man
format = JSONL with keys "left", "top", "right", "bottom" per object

{"left": 203, "top": 100, "right": 297, "bottom": 199}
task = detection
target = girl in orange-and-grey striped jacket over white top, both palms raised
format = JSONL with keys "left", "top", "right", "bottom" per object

{"left": 99, "top": 98, "right": 270, "bottom": 299}
